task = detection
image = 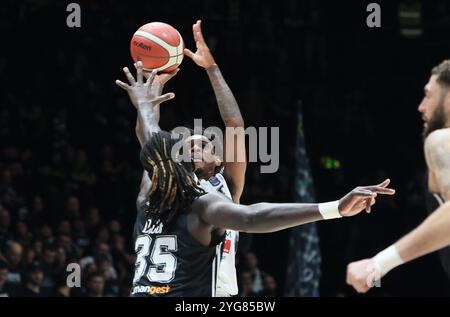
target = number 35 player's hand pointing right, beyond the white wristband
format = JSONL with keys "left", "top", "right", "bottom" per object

{"left": 339, "top": 179, "right": 395, "bottom": 217}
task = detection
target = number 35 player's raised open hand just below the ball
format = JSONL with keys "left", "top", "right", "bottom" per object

{"left": 116, "top": 62, "right": 175, "bottom": 108}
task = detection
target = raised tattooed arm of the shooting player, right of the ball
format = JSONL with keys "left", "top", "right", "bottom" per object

{"left": 185, "top": 20, "right": 247, "bottom": 203}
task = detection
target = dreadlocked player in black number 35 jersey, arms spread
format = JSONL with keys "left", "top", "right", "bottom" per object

{"left": 116, "top": 50, "right": 395, "bottom": 297}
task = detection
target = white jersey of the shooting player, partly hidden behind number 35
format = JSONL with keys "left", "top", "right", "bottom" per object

{"left": 200, "top": 174, "right": 239, "bottom": 297}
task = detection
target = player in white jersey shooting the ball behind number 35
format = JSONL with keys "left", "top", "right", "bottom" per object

{"left": 128, "top": 20, "right": 247, "bottom": 297}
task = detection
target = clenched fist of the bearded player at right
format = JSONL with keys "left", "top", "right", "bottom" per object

{"left": 346, "top": 259, "right": 382, "bottom": 293}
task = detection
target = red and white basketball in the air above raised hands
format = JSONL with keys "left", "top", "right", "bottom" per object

{"left": 130, "top": 22, "right": 184, "bottom": 73}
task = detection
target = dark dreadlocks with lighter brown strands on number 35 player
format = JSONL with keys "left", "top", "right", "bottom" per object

{"left": 140, "top": 131, "right": 205, "bottom": 227}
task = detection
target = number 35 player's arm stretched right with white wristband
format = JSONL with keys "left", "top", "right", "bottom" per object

{"left": 193, "top": 180, "right": 395, "bottom": 233}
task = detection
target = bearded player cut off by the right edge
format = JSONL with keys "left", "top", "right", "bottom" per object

{"left": 347, "top": 60, "right": 450, "bottom": 293}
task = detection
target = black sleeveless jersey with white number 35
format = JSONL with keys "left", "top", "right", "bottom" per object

{"left": 131, "top": 202, "right": 223, "bottom": 297}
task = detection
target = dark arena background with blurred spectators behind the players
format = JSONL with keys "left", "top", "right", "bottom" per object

{"left": 0, "top": 0, "right": 450, "bottom": 297}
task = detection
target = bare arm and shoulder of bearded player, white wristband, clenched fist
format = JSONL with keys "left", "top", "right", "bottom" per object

{"left": 347, "top": 129, "right": 450, "bottom": 293}
